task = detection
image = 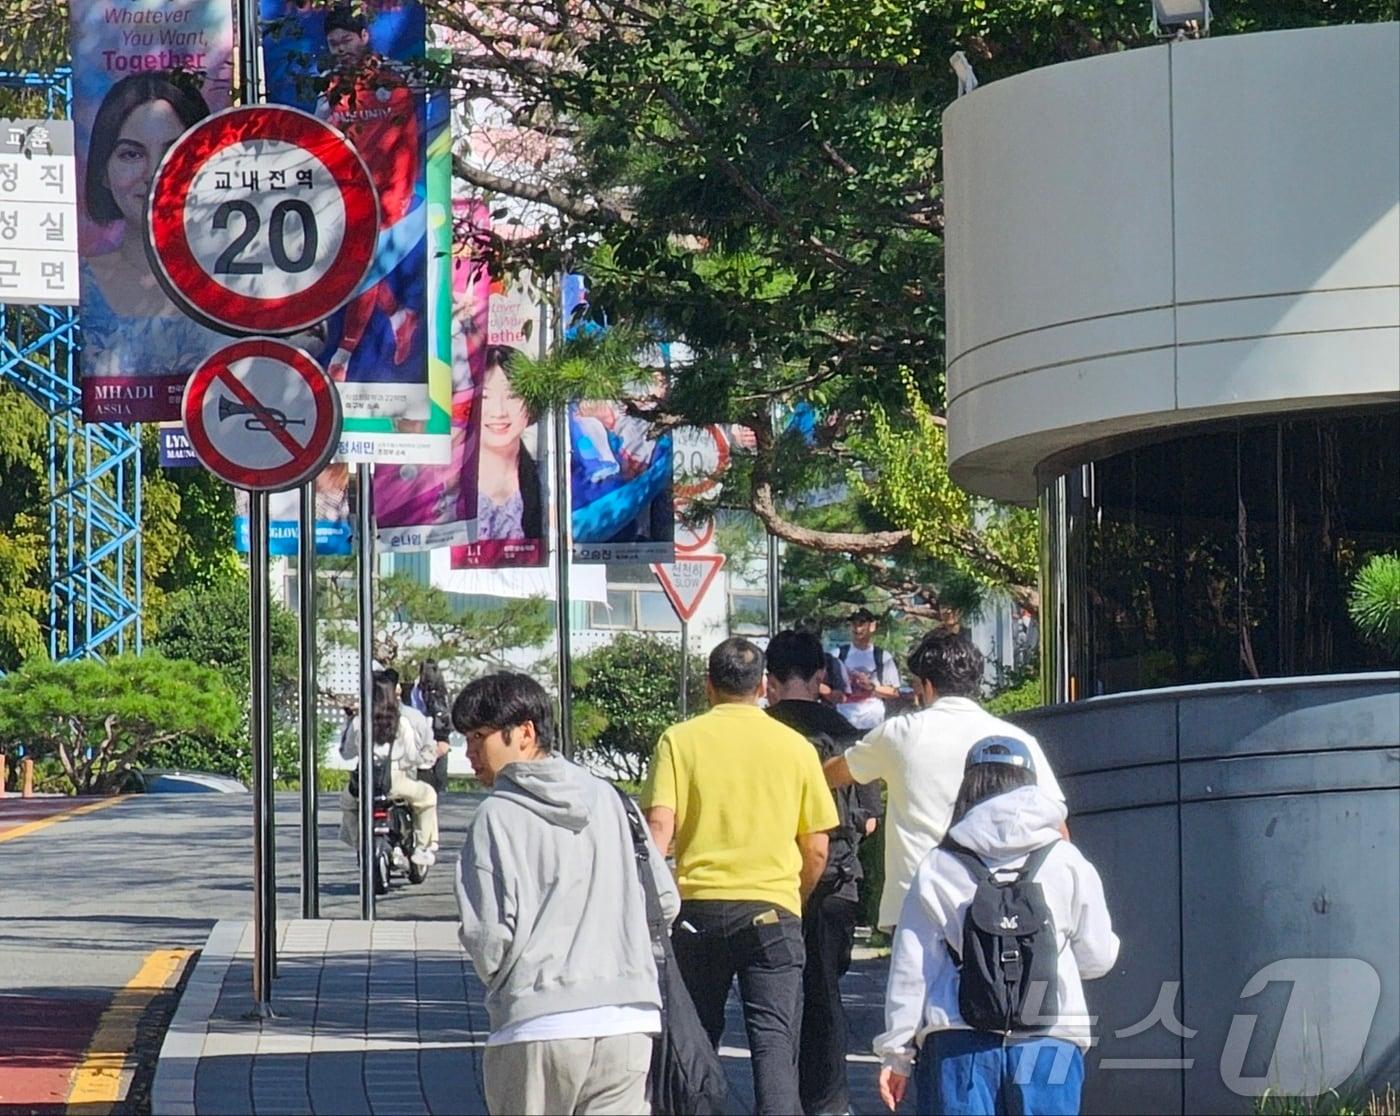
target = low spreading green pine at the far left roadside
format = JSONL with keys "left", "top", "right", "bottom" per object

{"left": 0, "top": 653, "right": 238, "bottom": 794}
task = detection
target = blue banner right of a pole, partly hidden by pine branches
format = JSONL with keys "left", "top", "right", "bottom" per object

{"left": 563, "top": 276, "right": 675, "bottom": 563}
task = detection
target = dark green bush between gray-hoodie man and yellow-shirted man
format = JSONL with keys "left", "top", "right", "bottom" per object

{"left": 571, "top": 634, "right": 704, "bottom": 780}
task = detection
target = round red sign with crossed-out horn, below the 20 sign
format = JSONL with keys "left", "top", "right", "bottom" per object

{"left": 181, "top": 337, "right": 340, "bottom": 491}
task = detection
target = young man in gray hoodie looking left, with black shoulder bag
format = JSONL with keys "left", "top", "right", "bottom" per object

{"left": 452, "top": 672, "right": 680, "bottom": 1113}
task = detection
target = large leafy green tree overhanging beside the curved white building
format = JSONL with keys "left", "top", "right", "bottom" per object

{"left": 431, "top": 0, "right": 1393, "bottom": 618}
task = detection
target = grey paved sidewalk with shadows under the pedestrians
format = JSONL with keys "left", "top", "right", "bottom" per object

{"left": 151, "top": 920, "right": 883, "bottom": 1116}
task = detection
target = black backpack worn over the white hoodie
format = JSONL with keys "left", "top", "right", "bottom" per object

{"left": 941, "top": 840, "right": 1060, "bottom": 1035}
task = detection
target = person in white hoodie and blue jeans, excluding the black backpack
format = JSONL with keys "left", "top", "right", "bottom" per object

{"left": 875, "top": 737, "right": 1119, "bottom": 1116}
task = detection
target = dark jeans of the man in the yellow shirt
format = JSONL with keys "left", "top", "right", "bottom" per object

{"left": 671, "top": 899, "right": 805, "bottom": 1116}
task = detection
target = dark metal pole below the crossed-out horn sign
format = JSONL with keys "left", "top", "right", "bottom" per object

{"left": 248, "top": 491, "right": 277, "bottom": 1015}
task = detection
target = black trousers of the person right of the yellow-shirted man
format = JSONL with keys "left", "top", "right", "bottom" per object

{"left": 798, "top": 885, "right": 860, "bottom": 1116}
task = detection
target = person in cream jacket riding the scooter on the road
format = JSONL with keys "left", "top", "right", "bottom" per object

{"left": 340, "top": 671, "right": 438, "bottom": 865}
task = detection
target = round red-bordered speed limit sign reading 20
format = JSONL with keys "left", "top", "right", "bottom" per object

{"left": 147, "top": 105, "right": 379, "bottom": 333}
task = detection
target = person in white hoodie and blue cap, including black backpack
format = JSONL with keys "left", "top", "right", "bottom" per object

{"left": 875, "top": 737, "right": 1119, "bottom": 1116}
